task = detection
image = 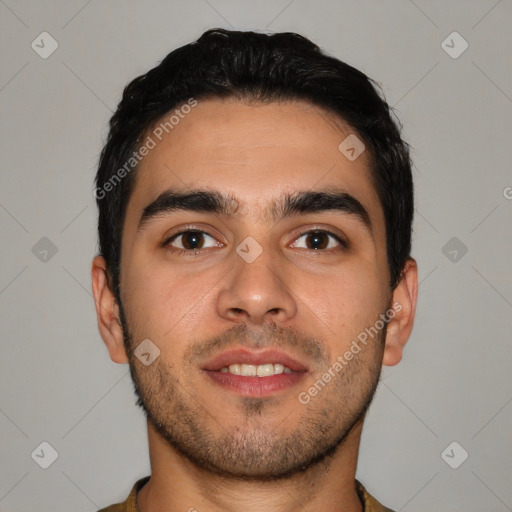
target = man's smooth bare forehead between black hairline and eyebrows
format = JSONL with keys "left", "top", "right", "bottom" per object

{"left": 126, "top": 99, "right": 381, "bottom": 232}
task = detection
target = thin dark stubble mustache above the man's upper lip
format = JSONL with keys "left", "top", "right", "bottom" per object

{"left": 185, "top": 323, "right": 329, "bottom": 364}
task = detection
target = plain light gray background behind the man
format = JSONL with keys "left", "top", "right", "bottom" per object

{"left": 0, "top": 0, "right": 512, "bottom": 512}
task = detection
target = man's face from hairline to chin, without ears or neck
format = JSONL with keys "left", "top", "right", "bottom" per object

{"left": 114, "top": 100, "right": 391, "bottom": 479}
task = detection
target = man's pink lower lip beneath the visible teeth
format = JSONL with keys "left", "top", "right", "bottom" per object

{"left": 203, "top": 370, "right": 307, "bottom": 397}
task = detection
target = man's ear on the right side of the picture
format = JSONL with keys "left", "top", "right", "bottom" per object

{"left": 382, "top": 258, "right": 418, "bottom": 366}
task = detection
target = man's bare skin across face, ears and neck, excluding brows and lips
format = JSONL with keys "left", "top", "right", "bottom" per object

{"left": 92, "top": 100, "right": 418, "bottom": 512}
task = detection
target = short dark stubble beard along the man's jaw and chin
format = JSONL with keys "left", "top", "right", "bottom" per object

{"left": 120, "top": 300, "right": 386, "bottom": 481}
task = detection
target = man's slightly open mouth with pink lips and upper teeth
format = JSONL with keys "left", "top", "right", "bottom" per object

{"left": 201, "top": 349, "right": 309, "bottom": 397}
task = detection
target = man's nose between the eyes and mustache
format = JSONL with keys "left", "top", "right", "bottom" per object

{"left": 217, "top": 239, "right": 297, "bottom": 324}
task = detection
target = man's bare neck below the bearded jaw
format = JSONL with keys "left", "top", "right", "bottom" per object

{"left": 137, "top": 420, "right": 363, "bottom": 512}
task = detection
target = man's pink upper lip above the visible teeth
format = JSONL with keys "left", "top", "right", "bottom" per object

{"left": 203, "top": 348, "right": 308, "bottom": 372}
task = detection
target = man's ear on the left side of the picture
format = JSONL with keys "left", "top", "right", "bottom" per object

{"left": 91, "top": 256, "right": 128, "bottom": 364}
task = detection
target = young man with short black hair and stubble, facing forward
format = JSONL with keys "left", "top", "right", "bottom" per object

{"left": 92, "top": 29, "right": 417, "bottom": 512}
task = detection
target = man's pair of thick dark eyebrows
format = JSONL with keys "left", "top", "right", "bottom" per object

{"left": 137, "top": 187, "right": 373, "bottom": 235}
